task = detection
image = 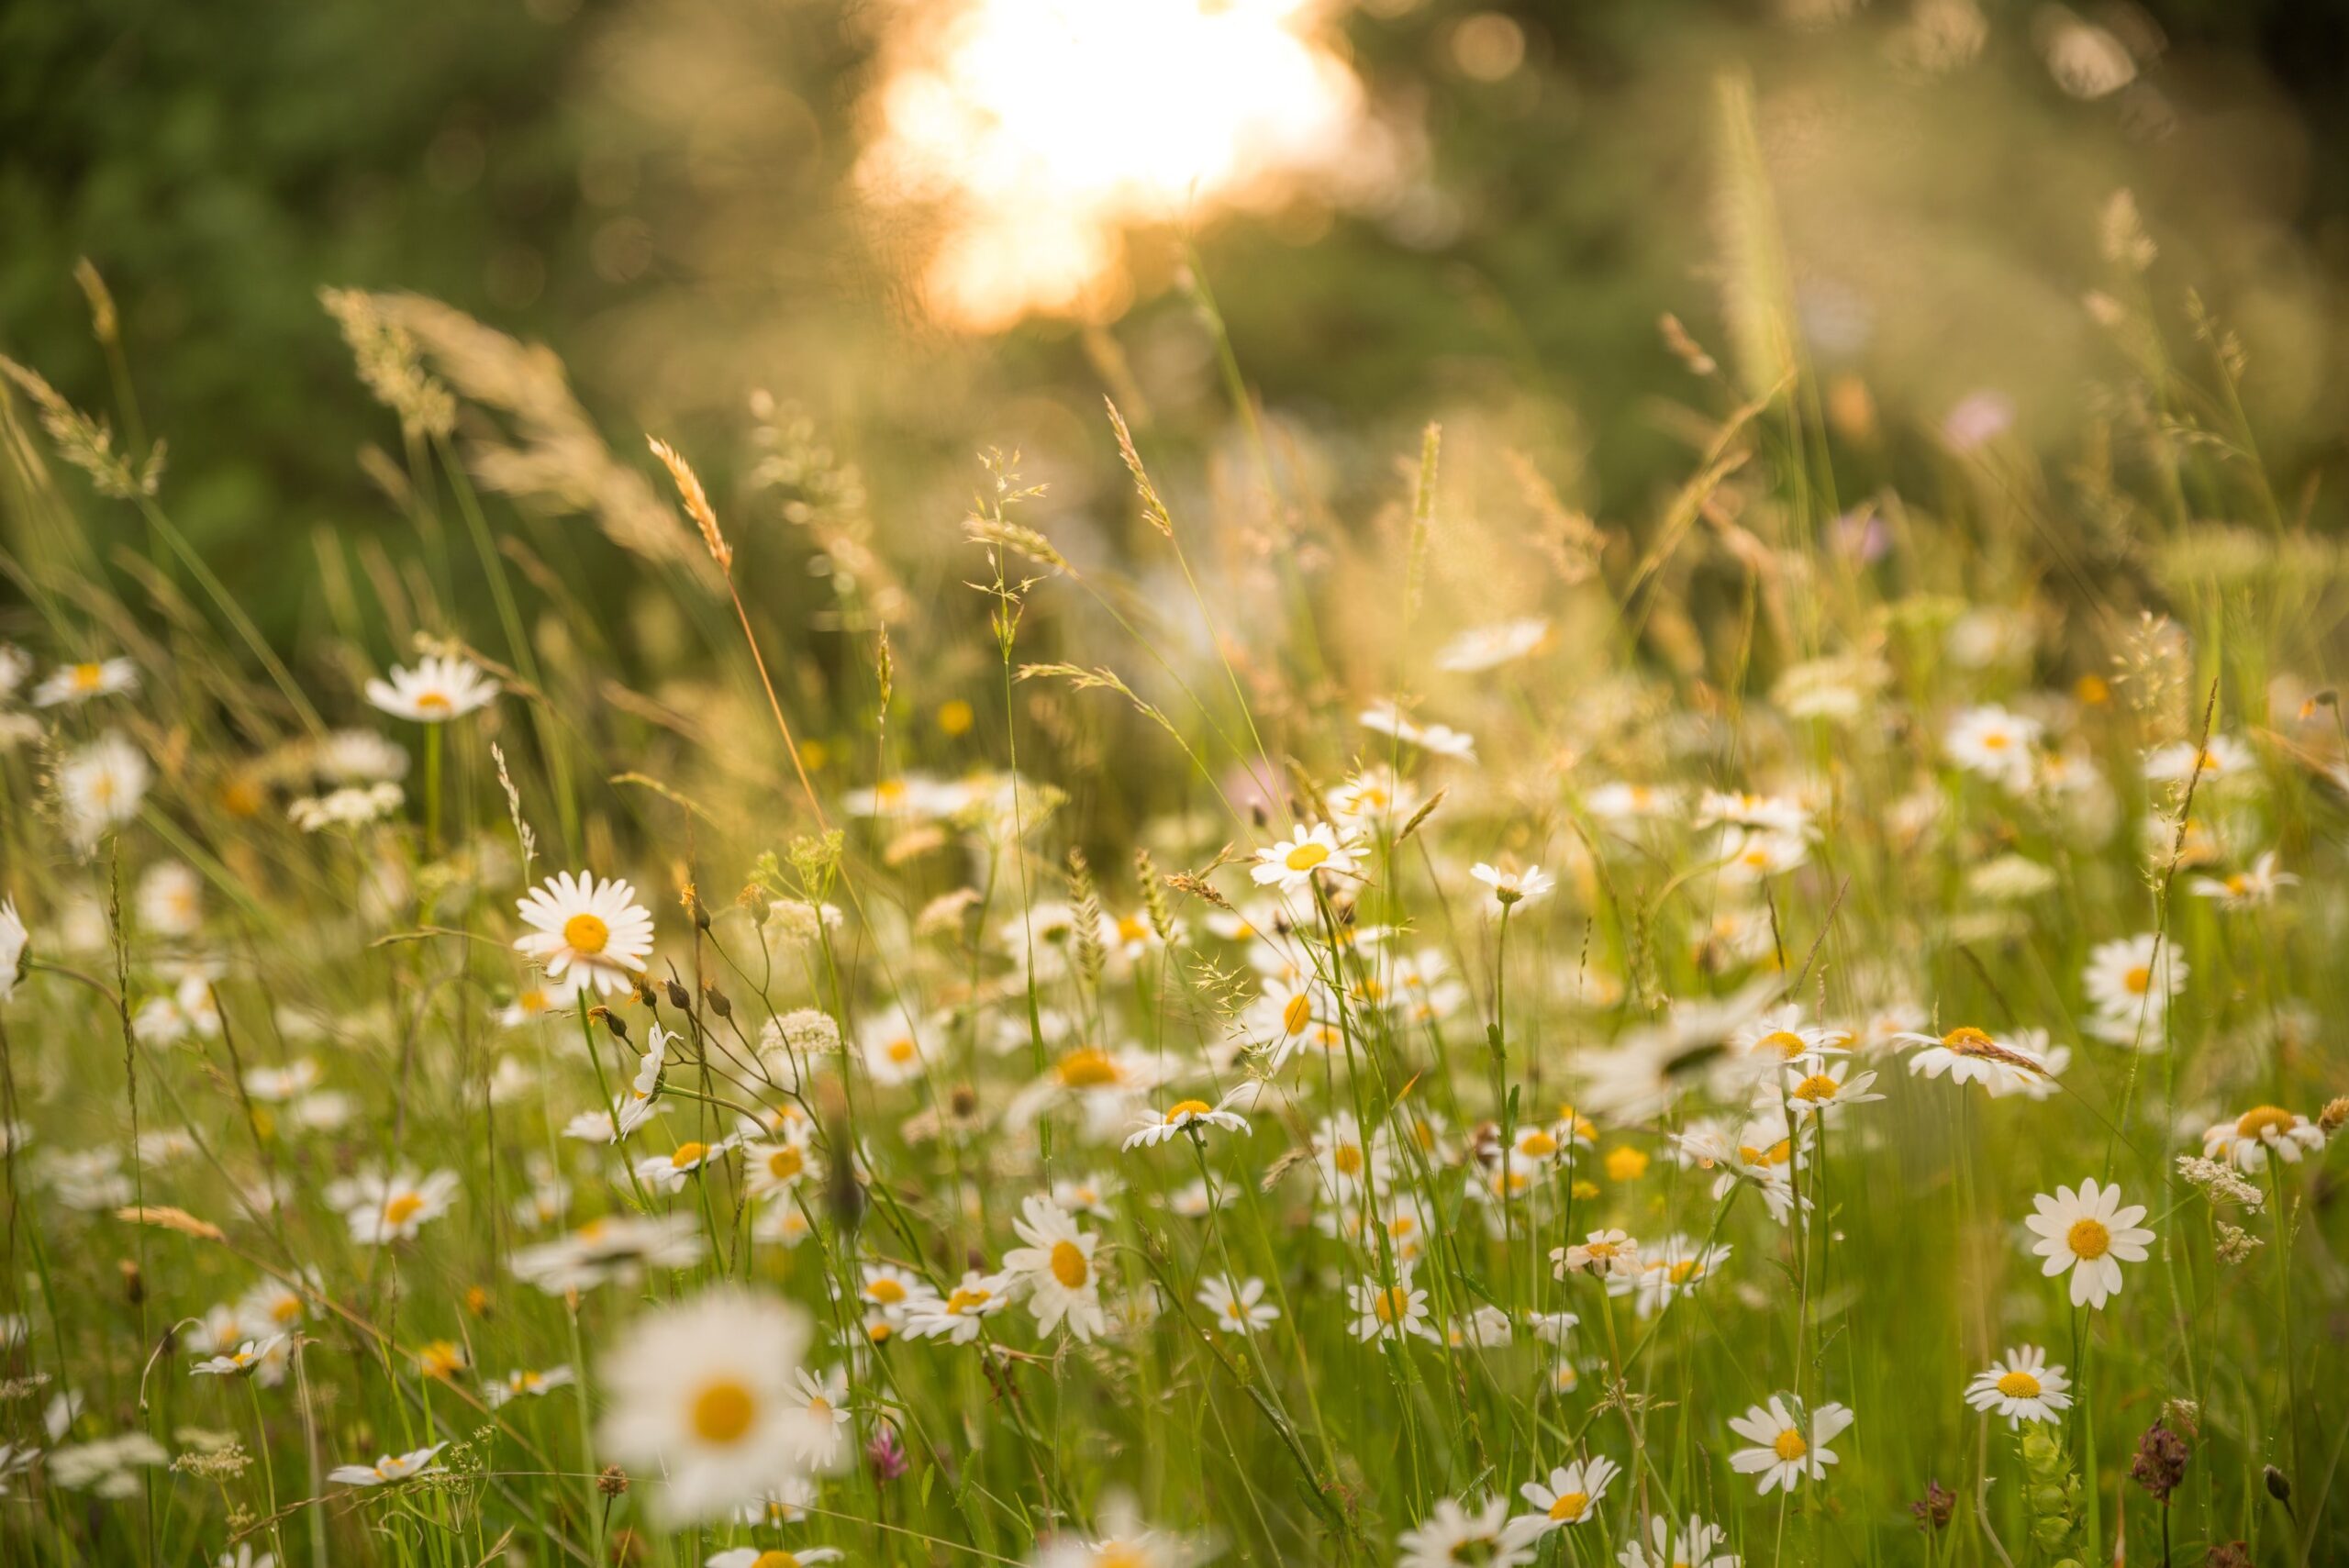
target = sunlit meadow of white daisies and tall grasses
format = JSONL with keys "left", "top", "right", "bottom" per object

{"left": 0, "top": 119, "right": 2349, "bottom": 1568}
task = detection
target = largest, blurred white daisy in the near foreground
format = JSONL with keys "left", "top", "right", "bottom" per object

{"left": 599, "top": 1286, "right": 810, "bottom": 1523}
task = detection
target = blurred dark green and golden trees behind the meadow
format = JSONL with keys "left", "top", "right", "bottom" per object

{"left": 0, "top": 0, "right": 2349, "bottom": 657}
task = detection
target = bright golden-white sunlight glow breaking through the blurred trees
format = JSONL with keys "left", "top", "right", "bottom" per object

{"left": 857, "top": 0, "right": 1393, "bottom": 331}
